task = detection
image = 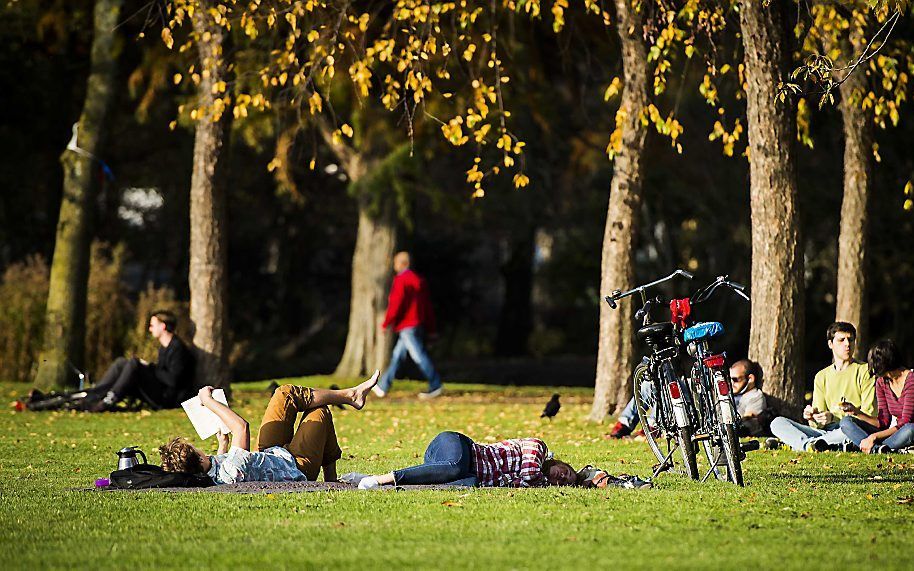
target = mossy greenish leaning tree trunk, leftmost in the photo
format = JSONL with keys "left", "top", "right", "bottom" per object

{"left": 35, "top": 0, "right": 122, "bottom": 390}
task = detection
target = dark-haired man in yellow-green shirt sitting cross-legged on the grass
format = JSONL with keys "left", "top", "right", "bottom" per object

{"left": 771, "top": 321, "right": 876, "bottom": 452}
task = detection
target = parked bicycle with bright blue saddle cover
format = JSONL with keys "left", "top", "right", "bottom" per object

{"left": 673, "top": 276, "right": 757, "bottom": 486}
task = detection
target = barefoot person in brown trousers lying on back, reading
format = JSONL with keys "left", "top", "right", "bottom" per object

{"left": 159, "top": 371, "right": 379, "bottom": 484}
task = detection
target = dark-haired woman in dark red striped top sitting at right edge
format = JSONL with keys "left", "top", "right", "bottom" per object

{"left": 841, "top": 340, "right": 914, "bottom": 454}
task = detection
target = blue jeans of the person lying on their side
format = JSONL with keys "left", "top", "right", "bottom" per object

{"left": 394, "top": 432, "right": 476, "bottom": 486}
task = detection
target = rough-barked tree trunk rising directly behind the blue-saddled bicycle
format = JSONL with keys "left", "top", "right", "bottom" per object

{"left": 740, "top": 0, "right": 804, "bottom": 413}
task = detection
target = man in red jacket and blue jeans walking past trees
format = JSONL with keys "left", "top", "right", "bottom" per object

{"left": 372, "top": 252, "right": 442, "bottom": 399}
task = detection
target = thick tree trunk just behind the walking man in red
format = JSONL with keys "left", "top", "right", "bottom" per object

{"left": 334, "top": 174, "right": 397, "bottom": 378}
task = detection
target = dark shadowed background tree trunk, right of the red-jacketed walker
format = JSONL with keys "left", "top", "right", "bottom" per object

{"left": 495, "top": 226, "right": 536, "bottom": 357}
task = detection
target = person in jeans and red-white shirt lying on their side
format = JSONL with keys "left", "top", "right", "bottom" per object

{"left": 342, "top": 432, "right": 577, "bottom": 490}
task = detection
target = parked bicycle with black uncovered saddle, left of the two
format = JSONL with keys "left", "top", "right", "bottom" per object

{"left": 604, "top": 270, "right": 699, "bottom": 480}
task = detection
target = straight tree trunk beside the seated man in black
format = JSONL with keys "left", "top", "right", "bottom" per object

{"left": 188, "top": 6, "right": 230, "bottom": 387}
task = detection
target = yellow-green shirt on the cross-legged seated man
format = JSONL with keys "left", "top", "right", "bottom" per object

{"left": 810, "top": 361, "right": 876, "bottom": 424}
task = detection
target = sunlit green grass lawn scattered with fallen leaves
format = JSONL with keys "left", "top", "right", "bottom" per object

{"left": 0, "top": 377, "right": 914, "bottom": 571}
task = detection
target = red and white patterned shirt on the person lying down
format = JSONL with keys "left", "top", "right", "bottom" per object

{"left": 473, "top": 438, "right": 549, "bottom": 488}
